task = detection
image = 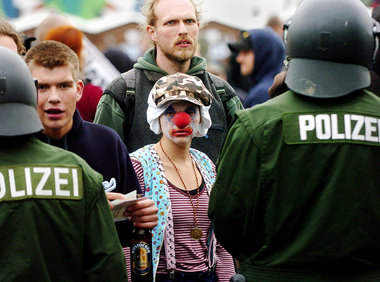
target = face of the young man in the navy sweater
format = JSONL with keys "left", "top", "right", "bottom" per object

{"left": 30, "top": 65, "right": 83, "bottom": 140}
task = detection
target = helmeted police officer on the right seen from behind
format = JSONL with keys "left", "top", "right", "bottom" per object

{"left": 209, "top": 0, "right": 380, "bottom": 282}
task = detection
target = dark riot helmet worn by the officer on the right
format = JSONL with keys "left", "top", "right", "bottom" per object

{"left": 284, "top": 0, "right": 379, "bottom": 98}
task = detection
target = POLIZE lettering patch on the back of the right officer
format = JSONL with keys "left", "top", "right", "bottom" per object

{"left": 283, "top": 113, "right": 380, "bottom": 145}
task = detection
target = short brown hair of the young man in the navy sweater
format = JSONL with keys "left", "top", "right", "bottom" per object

{"left": 25, "top": 40, "right": 79, "bottom": 81}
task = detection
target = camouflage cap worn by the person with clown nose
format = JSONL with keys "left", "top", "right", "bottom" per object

{"left": 151, "top": 72, "right": 212, "bottom": 107}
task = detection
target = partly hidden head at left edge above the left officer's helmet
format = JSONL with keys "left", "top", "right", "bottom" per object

{"left": 0, "top": 19, "right": 25, "bottom": 55}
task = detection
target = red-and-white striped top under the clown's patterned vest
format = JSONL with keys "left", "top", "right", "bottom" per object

{"left": 132, "top": 159, "right": 235, "bottom": 281}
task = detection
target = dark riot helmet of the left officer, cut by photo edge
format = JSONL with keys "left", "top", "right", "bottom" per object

{"left": 0, "top": 46, "right": 42, "bottom": 136}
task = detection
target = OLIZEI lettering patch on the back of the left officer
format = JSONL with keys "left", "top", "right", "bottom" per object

{"left": 0, "top": 166, "right": 83, "bottom": 201}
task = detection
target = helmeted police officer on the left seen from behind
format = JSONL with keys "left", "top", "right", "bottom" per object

{"left": 0, "top": 47, "right": 127, "bottom": 281}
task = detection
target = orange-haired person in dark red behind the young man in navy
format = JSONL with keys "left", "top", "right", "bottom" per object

{"left": 45, "top": 26, "right": 103, "bottom": 122}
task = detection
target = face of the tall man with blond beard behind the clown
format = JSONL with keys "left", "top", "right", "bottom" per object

{"left": 147, "top": 0, "right": 199, "bottom": 62}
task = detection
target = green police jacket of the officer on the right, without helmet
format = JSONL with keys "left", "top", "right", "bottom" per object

{"left": 209, "top": 91, "right": 380, "bottom": 281}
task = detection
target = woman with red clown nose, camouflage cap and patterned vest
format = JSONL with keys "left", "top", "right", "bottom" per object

{"left": 131, "top": 73, "right": 235, "bottom": 281}
